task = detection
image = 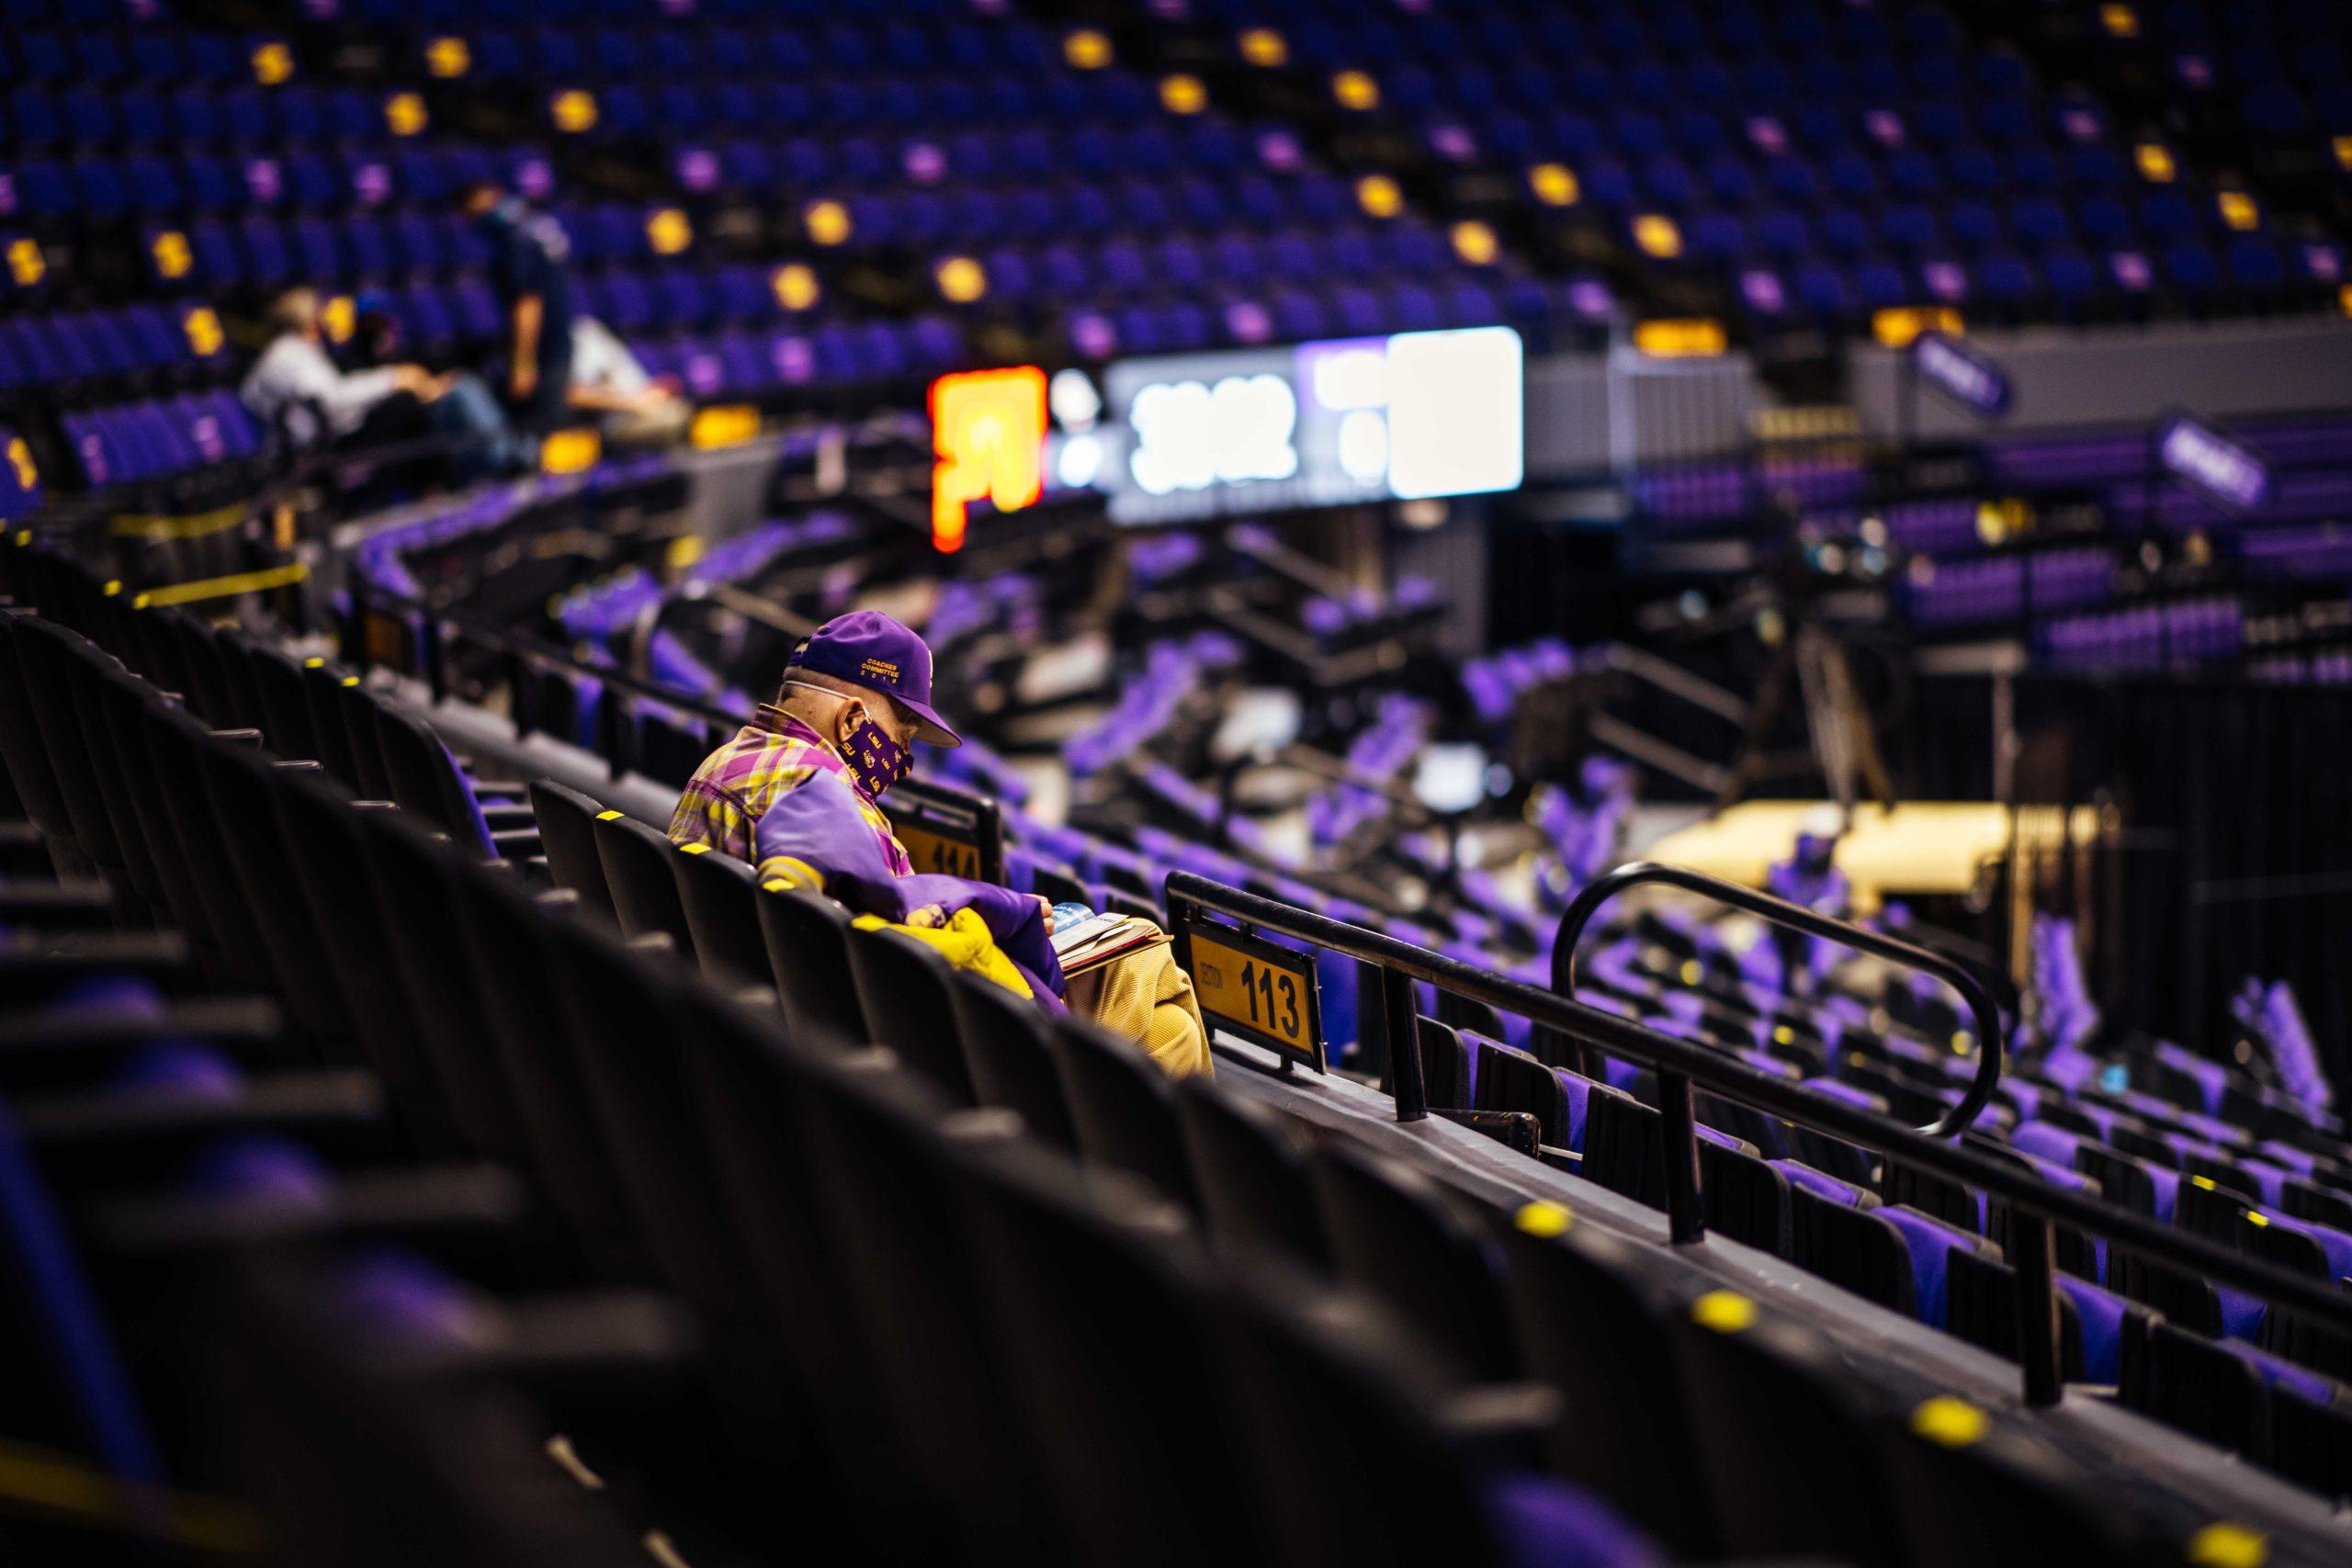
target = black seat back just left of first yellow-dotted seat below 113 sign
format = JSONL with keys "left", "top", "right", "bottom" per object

{"left": 1310, "top": 1143, "right": 1520, "bottom": 1384}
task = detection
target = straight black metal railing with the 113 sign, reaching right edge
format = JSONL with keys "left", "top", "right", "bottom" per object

{"left": 1167, "top": 872, "right": 2352, "bottom": 1405}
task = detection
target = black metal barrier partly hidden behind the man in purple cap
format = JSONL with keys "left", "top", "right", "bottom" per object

{"left": 344, "top": 571, "right": 1004, "bottom": 886}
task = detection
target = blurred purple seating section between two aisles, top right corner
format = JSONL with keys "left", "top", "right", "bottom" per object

{"left": 1161, "top": 0, "right": 2345, "bottom": 329}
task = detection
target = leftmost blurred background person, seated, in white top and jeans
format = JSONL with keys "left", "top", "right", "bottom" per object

{"left": 238, "top": 289, "right": 526, "bottom": 482}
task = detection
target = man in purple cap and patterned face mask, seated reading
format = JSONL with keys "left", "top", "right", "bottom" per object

{"left": 671, "top": 611, "right": 1211, "bottom": 1077}
